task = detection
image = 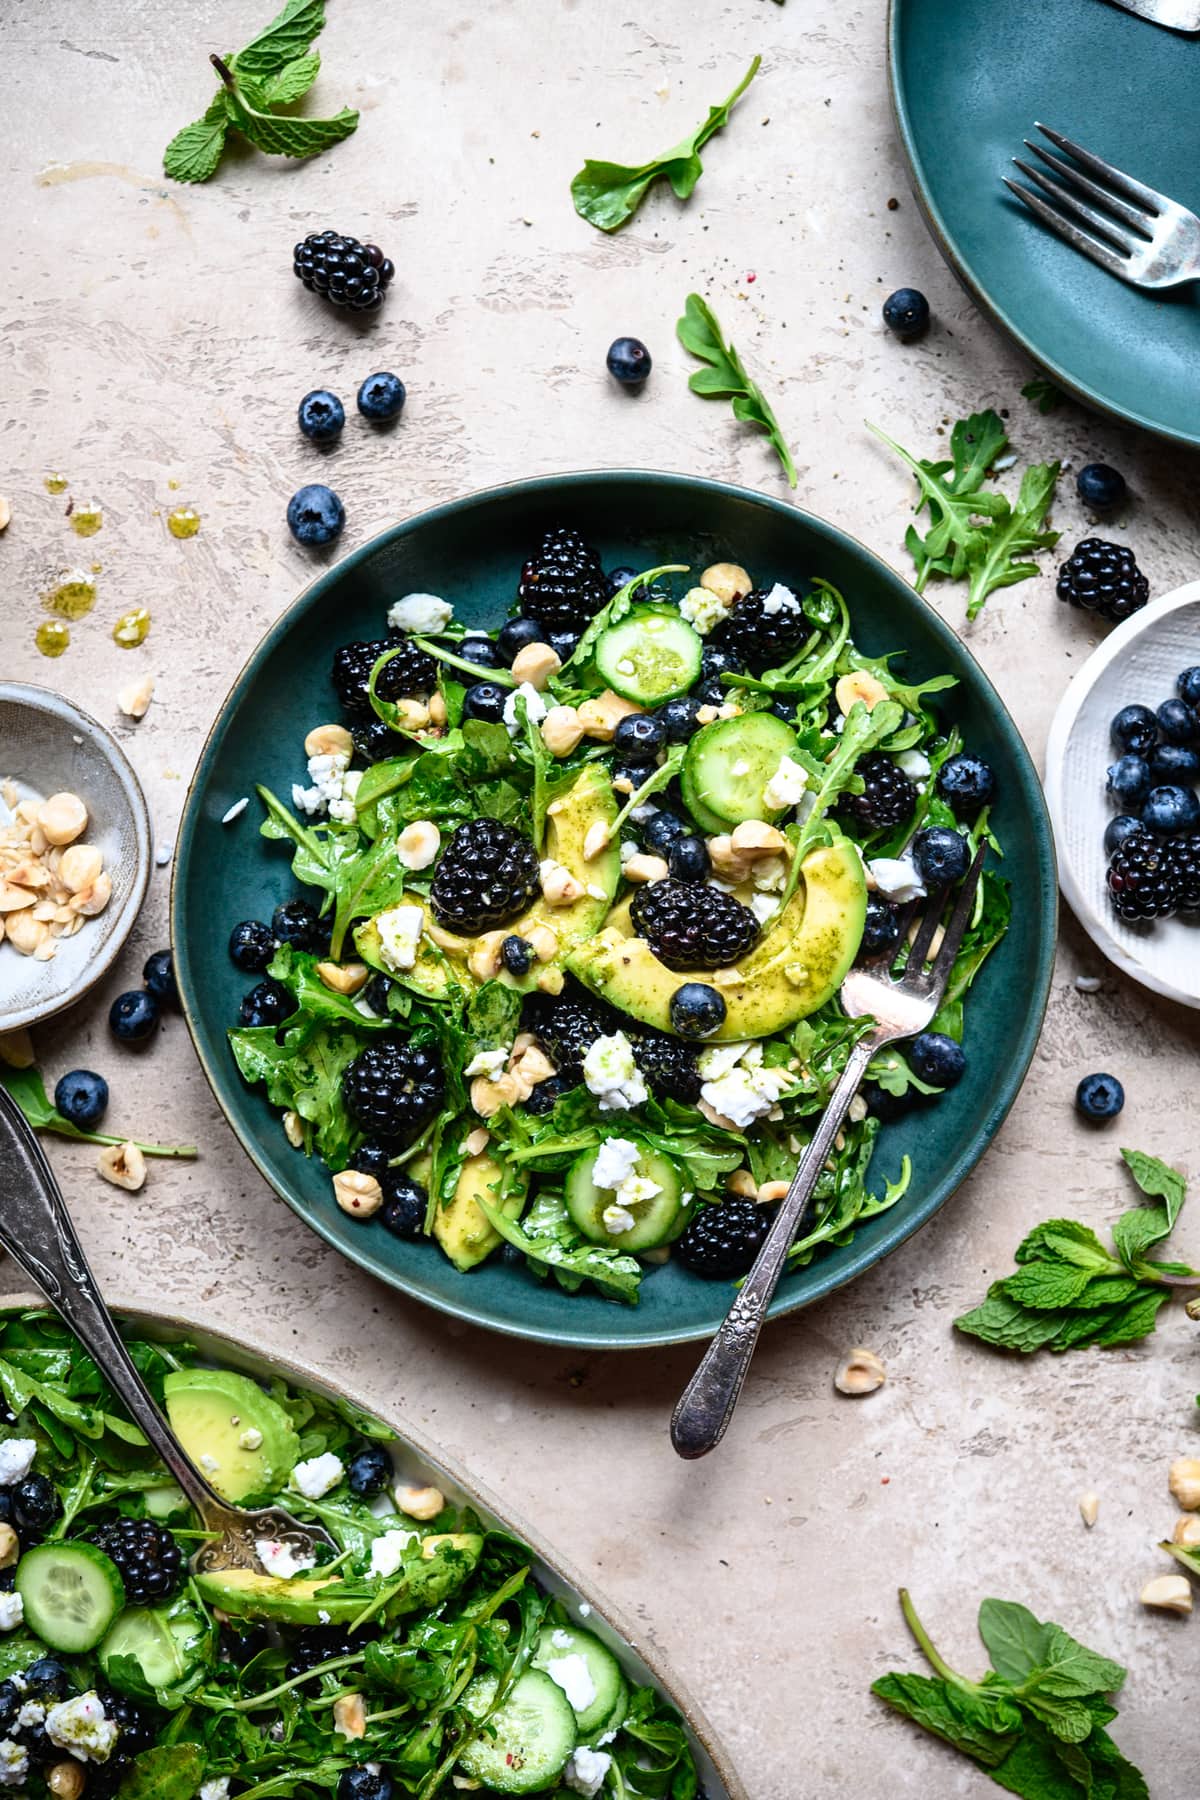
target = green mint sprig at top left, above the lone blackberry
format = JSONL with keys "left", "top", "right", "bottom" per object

{"left": 162, "top": 0, "right": 358, "bottom": 182}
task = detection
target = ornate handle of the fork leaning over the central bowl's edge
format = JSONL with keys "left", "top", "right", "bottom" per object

{"left": 671, "top": 1033, "right": 878, "bottom": 1460}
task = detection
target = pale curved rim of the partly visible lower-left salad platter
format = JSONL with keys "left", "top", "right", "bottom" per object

{"left": 0, "top": 1294, "right": 750, "bottom": 1800}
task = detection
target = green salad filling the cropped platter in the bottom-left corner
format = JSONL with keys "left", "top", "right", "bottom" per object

{"left": 0, "top": 1312, "right": 698, "bottom": 1800}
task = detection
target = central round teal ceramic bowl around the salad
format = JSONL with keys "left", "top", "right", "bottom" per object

{"left": 171, "top": 472, "right": 1056, "bottom": 1350}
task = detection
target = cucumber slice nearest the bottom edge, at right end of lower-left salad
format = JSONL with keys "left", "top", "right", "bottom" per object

{"left": 459, "top": 1669, "right": 579, "bottom": 1795}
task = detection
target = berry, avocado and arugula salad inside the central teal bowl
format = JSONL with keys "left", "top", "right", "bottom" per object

{"left": 230, "top": 526, "right": 1009, "bottom": 1301}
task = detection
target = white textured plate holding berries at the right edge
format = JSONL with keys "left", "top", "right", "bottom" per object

{"left": 1045, "top": 581, "right": 1200, "bottom": 1006}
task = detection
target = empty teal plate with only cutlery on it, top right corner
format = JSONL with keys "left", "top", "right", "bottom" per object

{"left": 889, "top": 0, "right": 1200, "bottom": 445}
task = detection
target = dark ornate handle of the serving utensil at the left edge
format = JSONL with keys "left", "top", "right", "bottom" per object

{"left": 0, "top": 1087, "right": 223, "bottom": 1517}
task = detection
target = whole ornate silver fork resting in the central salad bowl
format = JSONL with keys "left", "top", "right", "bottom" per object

{"left": 671, "top": 844, "right": 984, "bottom": 1458}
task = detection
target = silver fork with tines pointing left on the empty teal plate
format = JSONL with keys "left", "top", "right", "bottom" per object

{"left": 1000, "top": 122, "right": 1200, "bottom": 288}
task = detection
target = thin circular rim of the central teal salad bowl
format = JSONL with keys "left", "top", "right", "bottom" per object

{"left": 169, "top": 468, "right": 1058, "bottom": 1350}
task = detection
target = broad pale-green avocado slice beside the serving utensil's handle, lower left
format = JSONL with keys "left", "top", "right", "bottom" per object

{"left": 164, "top": 1368, "right": 300, "bottom": 1507}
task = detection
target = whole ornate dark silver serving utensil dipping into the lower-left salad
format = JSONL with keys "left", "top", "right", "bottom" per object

{"left": 0, "top": 1087, "right": 336, "bottom": 1573}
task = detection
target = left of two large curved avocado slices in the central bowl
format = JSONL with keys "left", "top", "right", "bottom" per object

{"left": 354, "top": 763, "right": 621, "bottom": 1001}
